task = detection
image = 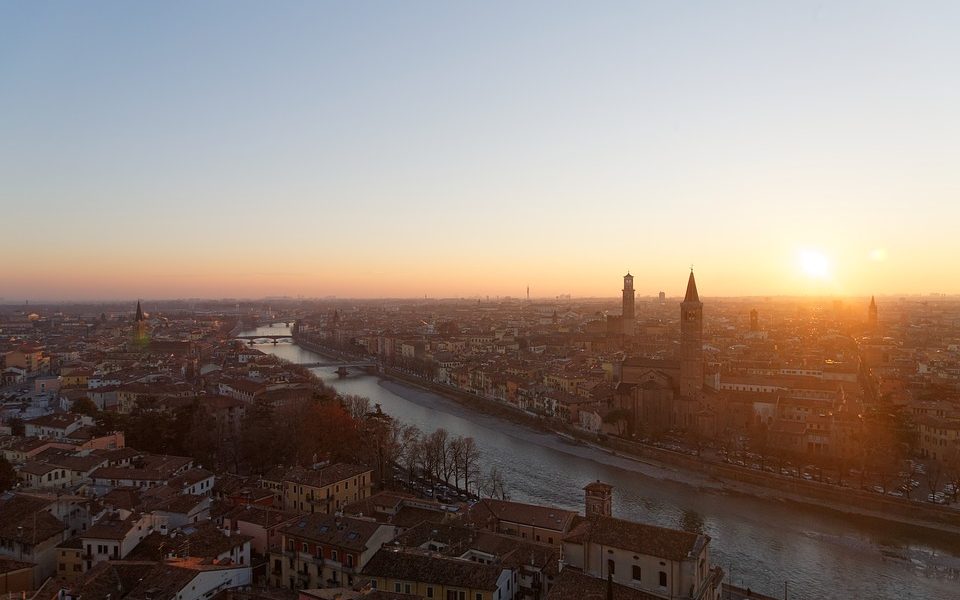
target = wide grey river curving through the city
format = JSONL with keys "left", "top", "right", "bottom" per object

{"left": 240, "top": 326, "right": 960, "bottom": 600}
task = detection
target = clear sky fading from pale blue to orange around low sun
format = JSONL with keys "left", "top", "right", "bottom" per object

{"left": 0, "top": 0, "right": 960, "bottom": 301}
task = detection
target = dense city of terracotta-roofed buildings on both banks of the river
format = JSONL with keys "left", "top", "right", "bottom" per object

{"left": 0, "top": 271, "right": 960, "bottom": 600}
